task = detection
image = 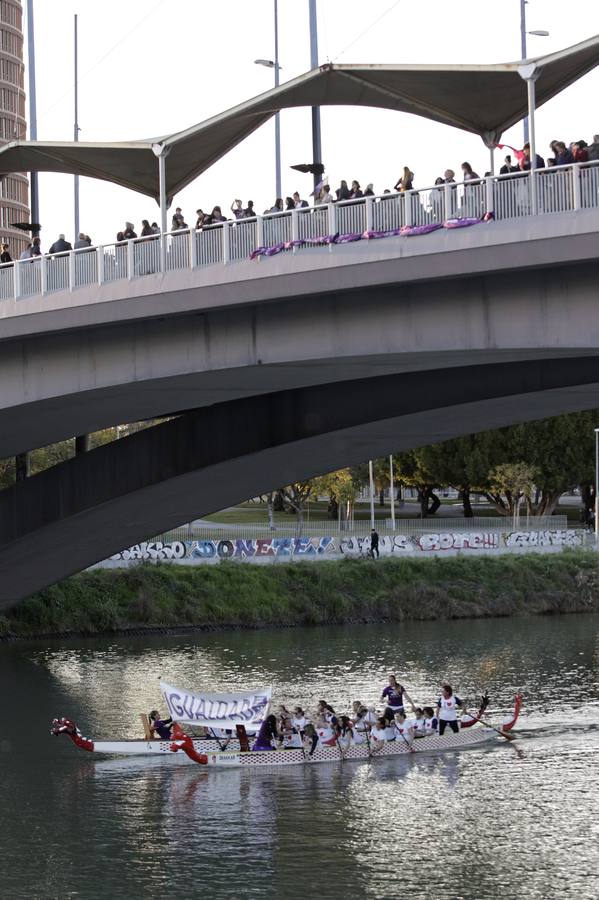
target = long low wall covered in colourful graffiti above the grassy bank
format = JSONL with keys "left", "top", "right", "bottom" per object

{"left": 110, "top": 530, "right": 583, "bottom": 563}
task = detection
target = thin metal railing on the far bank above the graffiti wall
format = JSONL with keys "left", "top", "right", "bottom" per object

{"left": 148, "top": 515, "right": 568, "bottom": 543}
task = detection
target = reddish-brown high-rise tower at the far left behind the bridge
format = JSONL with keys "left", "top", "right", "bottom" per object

{"left": 0, "top": 0, "right": 30, "bottom": 259}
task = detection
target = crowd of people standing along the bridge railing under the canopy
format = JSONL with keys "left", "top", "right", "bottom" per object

{"left": 5, "top": 134, "right": 599, "bottom": 263}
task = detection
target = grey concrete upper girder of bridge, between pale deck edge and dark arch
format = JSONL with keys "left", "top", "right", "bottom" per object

{"left": 0, "top": 253, "right": 599, "bottom": 458}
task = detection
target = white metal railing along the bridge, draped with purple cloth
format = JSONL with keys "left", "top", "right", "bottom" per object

{"left": 0, "top": 162, "right": 599, "bottom": 310}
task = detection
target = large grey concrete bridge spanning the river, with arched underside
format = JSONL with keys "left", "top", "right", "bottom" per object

{"left": 0, "top": 184, "right": 599, "bottom": 605}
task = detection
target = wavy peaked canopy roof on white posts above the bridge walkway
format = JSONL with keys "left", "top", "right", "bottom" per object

{"left": 0, "top": 35, "right": 599, "bottom": 200}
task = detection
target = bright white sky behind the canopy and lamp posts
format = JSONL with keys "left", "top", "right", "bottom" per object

{"left": 29, "top": 0, "right": 599, "bottom": 248}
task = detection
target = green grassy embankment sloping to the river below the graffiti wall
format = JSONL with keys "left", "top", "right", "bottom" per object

{"left": 0, "top": 551, "right": 599, "bottom": 638}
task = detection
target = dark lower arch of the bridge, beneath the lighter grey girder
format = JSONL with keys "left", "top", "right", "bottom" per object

{"left": 0, "top": 356, "right": 599, "bottom": 607}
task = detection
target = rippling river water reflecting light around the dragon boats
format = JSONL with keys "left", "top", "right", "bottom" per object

{"left": 0, "top": 616, "right": 599, "bottom": 900}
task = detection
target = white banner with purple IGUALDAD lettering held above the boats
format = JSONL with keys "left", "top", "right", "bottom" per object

{"left": 160, "top": 681, "right": 272, "bottom": 731}
